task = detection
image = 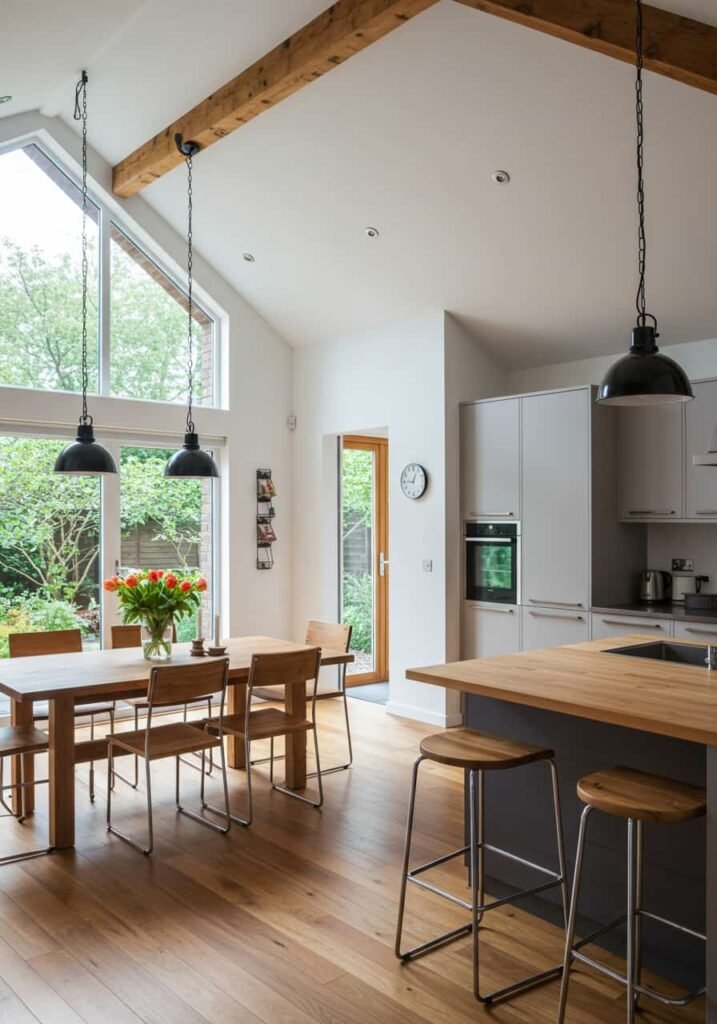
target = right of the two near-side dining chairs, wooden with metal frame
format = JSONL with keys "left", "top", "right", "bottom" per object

{"left": 202, "top": 647, "right": 324, "bottom": 825}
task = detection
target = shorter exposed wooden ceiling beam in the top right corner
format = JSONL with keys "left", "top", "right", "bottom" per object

{"left": 458, "top": 0, "right": 717, "bottom": 93}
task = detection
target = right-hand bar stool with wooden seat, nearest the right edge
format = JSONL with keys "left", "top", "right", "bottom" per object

{"left": 557, "top": 768, "right": 707, "bottom": 1024}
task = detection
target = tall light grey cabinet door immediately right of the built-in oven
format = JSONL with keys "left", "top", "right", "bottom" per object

{"left": 520, "top": 388, "right": 590, "bottom": 608}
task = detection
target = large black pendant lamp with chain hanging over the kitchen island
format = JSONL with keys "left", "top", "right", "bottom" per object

{"left": 597, "top": 0, "right": 694, "bottom": 406}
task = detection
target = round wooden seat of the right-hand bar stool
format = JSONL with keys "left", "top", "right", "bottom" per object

{"left": 578, "top": 768, "right": 707, "bottom": 821}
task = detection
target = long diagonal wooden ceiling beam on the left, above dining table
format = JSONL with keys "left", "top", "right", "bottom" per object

{"left": 113, "top": 0, "right": 437, "bottom": 197}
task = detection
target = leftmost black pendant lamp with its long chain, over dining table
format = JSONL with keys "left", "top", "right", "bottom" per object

{"left": 54, "top": 71, "right": 117, "bottom": 476}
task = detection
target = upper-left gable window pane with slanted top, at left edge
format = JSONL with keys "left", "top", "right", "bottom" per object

{"left": 0, "top": 145, "right": 99, "bottom": 391}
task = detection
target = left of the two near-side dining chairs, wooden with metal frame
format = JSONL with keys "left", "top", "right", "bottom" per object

{"left": 107, "top": 658, "right": 231, "bottom": 856}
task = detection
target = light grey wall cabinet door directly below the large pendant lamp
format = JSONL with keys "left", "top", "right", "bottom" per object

{"left": 618, "top": 402, "right": 684, "bottom": 522}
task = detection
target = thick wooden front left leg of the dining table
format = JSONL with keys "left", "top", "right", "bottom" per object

{"left": 49, "top": 697, "right": 75, "bottom": 850}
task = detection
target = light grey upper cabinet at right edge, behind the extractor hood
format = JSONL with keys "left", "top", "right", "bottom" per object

{"left": 684, "top": 381, "right": 717, "bottom": 520}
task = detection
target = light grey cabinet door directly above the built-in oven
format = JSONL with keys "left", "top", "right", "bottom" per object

{"left": 461, "top": 398, "right": 520, "bottom": 519}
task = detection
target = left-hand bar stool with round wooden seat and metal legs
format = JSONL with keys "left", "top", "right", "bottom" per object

{"left": 395, "top": 729, "right": 567, "bottom": 1002}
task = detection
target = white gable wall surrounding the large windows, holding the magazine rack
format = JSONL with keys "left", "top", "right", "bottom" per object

{"left": 0, "top": 113, "right": 292, "bottom": 636}
